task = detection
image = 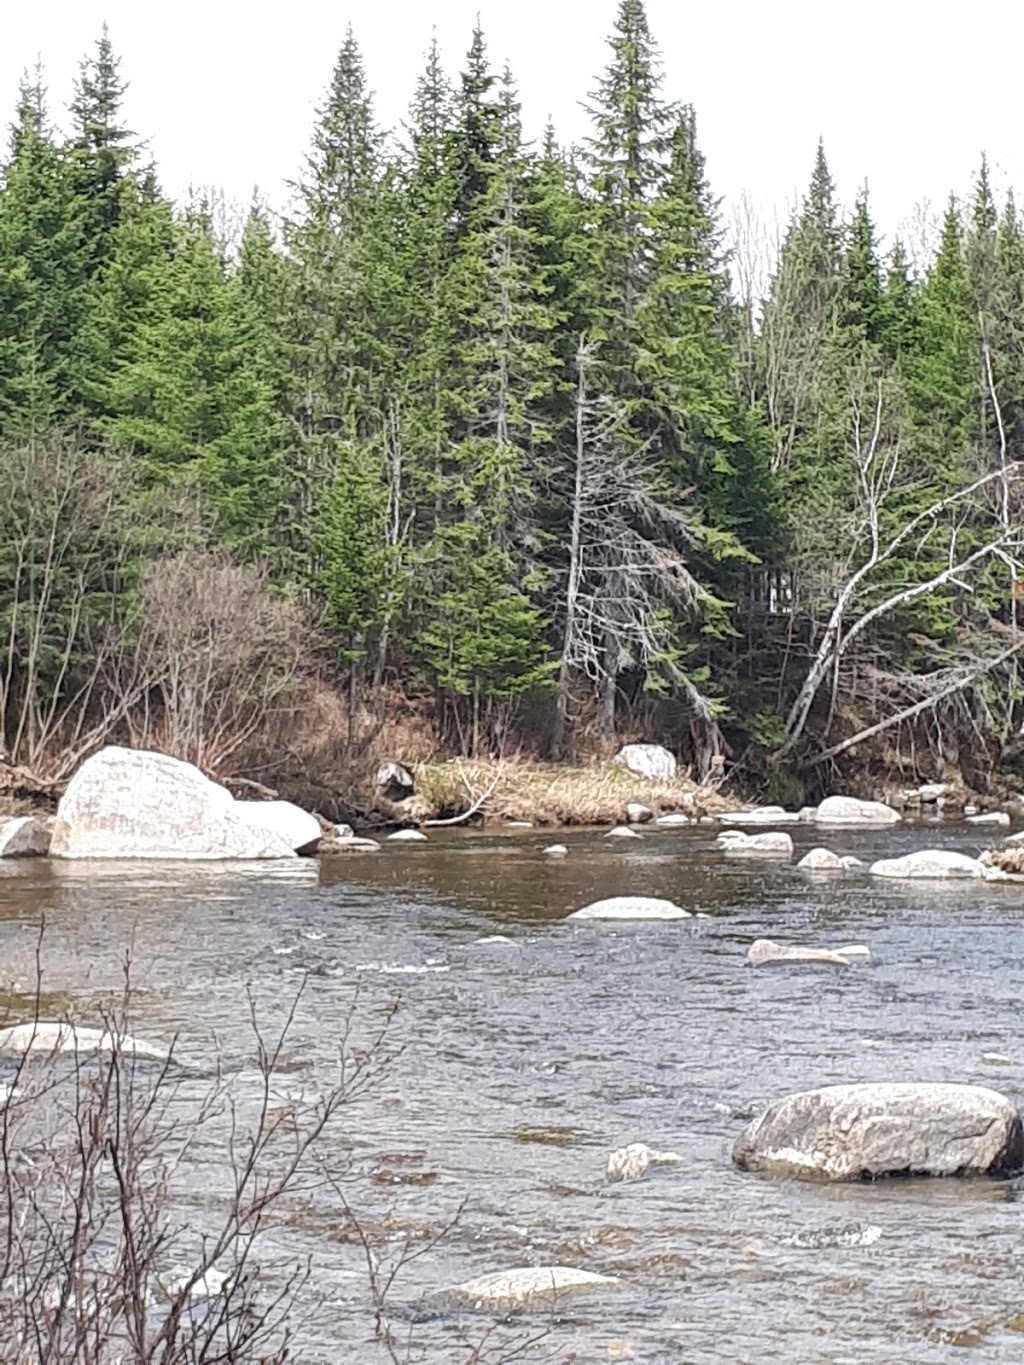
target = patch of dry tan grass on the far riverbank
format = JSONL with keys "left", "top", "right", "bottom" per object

{"left": 415, "top": 759, "right": 736, "bottom": 824}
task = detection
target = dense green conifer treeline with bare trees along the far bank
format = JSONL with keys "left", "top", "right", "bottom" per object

{"left": 0, "top": 0, "right": 1024, "bottom": 786}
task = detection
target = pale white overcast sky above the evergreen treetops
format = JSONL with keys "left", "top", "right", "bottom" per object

{"left": 0, "top": 0, "right": 1024, "bottom": 263}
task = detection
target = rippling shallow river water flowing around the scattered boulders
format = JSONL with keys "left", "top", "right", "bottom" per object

{"left": 0, "top": 826, "right": 1024, "bottom": 1365}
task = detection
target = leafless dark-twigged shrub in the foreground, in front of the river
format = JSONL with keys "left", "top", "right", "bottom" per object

{"left": 0, "top": 966, "right": 390, "bottom": 1365}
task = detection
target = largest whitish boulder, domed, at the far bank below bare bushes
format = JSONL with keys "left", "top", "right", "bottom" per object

{"left": 51, "top": 747, "right": 294, "bottom": 860}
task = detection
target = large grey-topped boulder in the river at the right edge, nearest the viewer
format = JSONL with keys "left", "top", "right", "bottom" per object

{"left": 732, "top": 1082, "right": 1024, "bottom": 1181}
